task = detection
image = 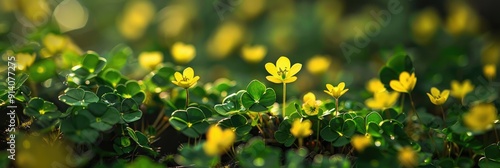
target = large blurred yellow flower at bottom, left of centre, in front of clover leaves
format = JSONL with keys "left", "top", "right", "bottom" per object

{"left": 203, "top": 125, "right": 236, "bottom": 156}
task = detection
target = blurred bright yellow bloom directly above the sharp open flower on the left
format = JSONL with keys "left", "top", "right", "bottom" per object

{"left": 171, "top": 42, "right": 196, "bottom": 64}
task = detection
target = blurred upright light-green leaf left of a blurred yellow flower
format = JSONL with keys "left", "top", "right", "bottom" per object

{"left": 106, "top": 44, "right": 132, "bottom": 69}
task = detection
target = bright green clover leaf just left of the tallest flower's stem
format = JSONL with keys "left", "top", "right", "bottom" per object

{"left": 241, "top": 80, "right": 276, "bottom": 112}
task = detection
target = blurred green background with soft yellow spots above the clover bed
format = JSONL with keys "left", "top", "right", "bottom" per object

{"left": 0, "top": 0, "right": 500, "bottom": 103}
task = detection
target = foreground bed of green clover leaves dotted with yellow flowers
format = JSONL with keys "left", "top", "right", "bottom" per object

{"left": 0, "top": 46, "right": 500, "bottom": 167}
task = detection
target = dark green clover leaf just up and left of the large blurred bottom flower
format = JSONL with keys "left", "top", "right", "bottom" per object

{"left": 169, "top": 107, "right": 209, "bottom": 138}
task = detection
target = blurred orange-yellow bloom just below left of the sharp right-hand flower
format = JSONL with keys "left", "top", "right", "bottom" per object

{"left": 365, "top": 91, "right": 399, "bottom": 110}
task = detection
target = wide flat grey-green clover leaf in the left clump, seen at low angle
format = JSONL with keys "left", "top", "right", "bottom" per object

{"left": 59, "top": 88, "right": 99, "bottom": 106}
